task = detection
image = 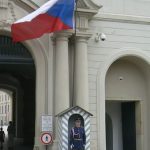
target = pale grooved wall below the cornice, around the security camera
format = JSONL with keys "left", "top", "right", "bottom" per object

{"left": 88, "top": 18, "right": 150, "bottom": 150}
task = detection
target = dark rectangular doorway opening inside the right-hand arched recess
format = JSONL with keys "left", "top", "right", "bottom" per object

{"left": 106, "top": 101, "right": 136, "bottom": 150}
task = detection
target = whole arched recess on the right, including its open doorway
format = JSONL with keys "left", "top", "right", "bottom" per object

{"left": 105, "top": 56, "right": 150, "bottom": 150}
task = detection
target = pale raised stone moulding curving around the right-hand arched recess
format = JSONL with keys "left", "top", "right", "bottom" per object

{"left": 97, "top": 47, "right": 150, "bottom": 150}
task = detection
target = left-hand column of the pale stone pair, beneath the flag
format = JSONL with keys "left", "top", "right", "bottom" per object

{"left": 54, "top": 33, "right": 70, "bottom": 115}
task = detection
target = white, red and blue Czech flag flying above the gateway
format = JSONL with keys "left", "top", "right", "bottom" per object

{"left": 11, "top": 0, "right": 75, "bottom": 42}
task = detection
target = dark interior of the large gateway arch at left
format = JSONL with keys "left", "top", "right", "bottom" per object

{"left": 0, "top": 35, "right": 36, "bottom": 150}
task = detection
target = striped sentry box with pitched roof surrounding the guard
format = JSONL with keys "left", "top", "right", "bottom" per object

{"left": 56, "top": 106, "right": 93, "bottom": 150}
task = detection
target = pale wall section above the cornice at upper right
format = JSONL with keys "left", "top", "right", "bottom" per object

{"left": 99, "top": 0, "right": 150, "bottom": 17}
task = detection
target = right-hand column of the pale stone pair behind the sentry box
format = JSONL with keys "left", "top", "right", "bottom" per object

{"left": 74, "top": 36, "right": 89, "bottom": 111}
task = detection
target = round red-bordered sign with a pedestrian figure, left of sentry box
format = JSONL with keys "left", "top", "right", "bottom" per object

{"left": 41, "top": 133, "right": 53, "bottom": 145}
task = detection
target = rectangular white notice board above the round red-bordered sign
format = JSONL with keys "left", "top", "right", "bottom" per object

{"left": 42, "top": 115, "right": 53, "bottom": 132}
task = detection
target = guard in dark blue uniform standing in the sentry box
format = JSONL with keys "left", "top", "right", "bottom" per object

{"left": 70, "top": 118, "right": 86, "bottom": 150}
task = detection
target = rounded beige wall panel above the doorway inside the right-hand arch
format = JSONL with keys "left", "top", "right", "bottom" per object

{"left": 106, "top": 58, "right": 147, "bottom": 100}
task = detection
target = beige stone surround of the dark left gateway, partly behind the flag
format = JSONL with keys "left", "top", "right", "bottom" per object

{"left": 0, "top": 28, "right": 48, "bottom": 147}
